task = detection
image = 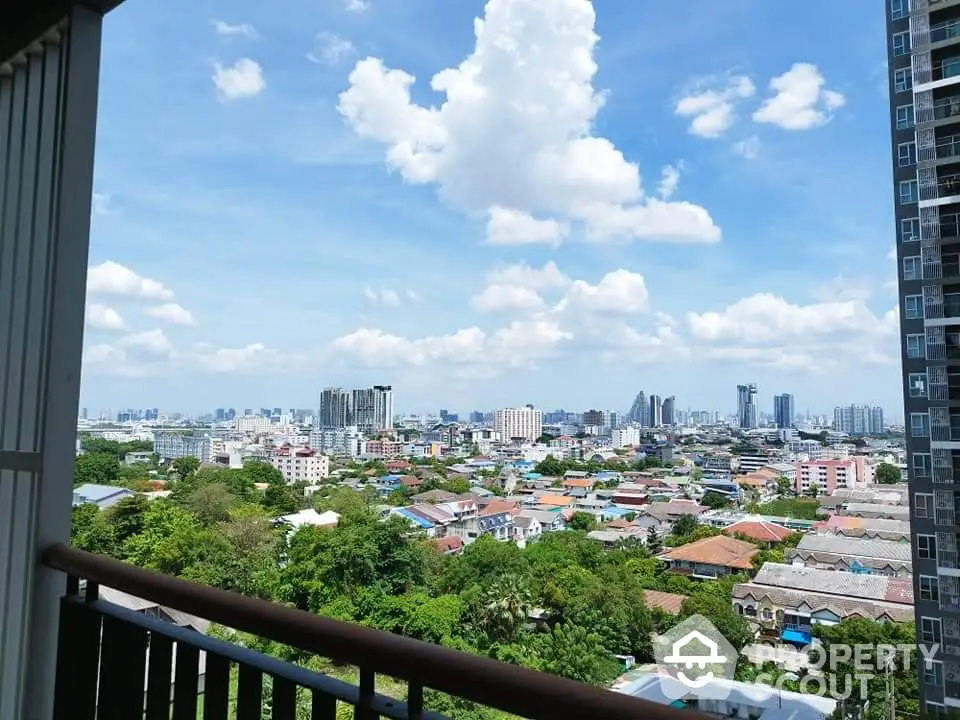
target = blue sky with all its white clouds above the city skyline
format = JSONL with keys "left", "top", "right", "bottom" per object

{"left": 82, "top": 0, "right": 902, "bottom": 416}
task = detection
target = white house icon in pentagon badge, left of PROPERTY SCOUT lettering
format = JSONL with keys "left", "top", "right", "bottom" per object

{"left": 653, "top": 615, "right": 738, "bottom": 700}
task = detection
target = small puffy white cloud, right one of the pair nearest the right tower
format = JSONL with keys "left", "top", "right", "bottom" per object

{"left": 753, "top": 63, "right": 847, "bottom": 130}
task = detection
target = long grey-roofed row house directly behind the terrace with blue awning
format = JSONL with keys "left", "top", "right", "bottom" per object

{"left": 786, "top": 535, "right": 913, "bottom": 578}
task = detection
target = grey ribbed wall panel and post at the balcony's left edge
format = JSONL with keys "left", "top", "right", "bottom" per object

{"left": 0, "top": 8, "right": 101, "bottom": 720}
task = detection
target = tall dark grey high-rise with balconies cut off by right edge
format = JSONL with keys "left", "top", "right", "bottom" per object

{"left": 878, "top": 0, "right": 960, "bottom": 714}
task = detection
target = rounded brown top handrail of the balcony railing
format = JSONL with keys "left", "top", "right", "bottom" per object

{"left": 42, "top": 544, "right": 691, "bottom": 720}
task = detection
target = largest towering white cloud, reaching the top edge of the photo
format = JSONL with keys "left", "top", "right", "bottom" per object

{"left": 339, "top": 0, "right": 720, "bottom": 244}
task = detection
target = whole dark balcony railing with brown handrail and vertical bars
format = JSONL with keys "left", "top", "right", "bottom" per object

{"left": 43, "top": 545, "right": 676, "bottom": 720}
